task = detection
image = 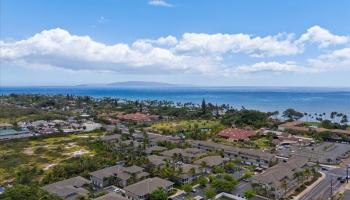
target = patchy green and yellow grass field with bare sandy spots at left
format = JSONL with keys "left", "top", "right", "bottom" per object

{"left": 0, "top": 132, "right": 102, "bottom": 184}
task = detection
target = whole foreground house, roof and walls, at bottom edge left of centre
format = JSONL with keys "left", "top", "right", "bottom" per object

{"left": 124, "top": 177, "right": 174, "bottom": 200}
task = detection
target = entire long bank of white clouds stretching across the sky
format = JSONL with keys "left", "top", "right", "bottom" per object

{"left": 0, "top": 28, "right": 350, "bottom": 75}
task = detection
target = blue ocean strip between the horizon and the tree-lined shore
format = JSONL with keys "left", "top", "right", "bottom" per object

{"left": 0, "top": 87, "right": 350, "bottom": 116}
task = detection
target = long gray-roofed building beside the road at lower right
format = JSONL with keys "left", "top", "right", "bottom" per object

{"left": 252, "top": 156, "right": 311, "bottom": 199}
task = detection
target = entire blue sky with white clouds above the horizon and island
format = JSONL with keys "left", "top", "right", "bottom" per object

{"left": 0, "top": 0, "right": 350, "bottom": 87}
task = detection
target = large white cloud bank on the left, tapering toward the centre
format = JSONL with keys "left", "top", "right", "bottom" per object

{"left": 0, "top": 28, "right": 216, "bottom": 73}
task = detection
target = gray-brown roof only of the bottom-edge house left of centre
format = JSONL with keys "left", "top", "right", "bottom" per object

{"left": 124, "top": 177, "right": 174, "bottom": 196}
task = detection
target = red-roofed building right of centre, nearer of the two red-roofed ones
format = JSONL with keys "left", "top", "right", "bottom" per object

{"left": 218, "top": 128, "right": 256, "bottom": 141}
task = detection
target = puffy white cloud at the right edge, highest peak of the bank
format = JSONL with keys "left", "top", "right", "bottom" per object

{"left": 297, "top": 26, "right": 350, "bottom": 48}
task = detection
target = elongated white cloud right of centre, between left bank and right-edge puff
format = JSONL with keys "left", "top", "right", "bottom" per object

{"left": 175, "top": 33, "right": 302, "bottom": 57}
